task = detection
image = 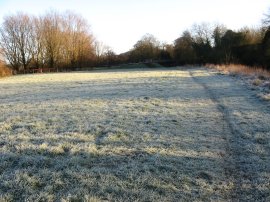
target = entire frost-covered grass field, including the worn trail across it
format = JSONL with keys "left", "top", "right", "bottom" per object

{"left": 0, "top": 68, "right": 270, "bottom": 201}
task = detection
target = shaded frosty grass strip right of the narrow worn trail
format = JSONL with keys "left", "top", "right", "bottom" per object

{"left": 189, "top": 70, "right": 270, "bottom": 201}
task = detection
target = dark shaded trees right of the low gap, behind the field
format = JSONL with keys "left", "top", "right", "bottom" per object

{"left": 126, "top": 17, "right": 270, "bottom": 69}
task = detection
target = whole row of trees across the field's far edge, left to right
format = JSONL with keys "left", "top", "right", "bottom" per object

{"left": 0, "top": 10, "right": 270, "bottom": 72}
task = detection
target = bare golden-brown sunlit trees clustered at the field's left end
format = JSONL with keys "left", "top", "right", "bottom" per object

{"left": 0, "top": 11, "right": 95, "bottom": 71}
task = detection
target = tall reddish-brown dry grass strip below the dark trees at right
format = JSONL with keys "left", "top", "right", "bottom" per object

{"left": 206, "top": 64, "right": 270, "bottom": 78}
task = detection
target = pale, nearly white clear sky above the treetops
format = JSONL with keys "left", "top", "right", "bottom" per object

{"left": 0, "top": 0, "right": 270, "bottom": 53}
